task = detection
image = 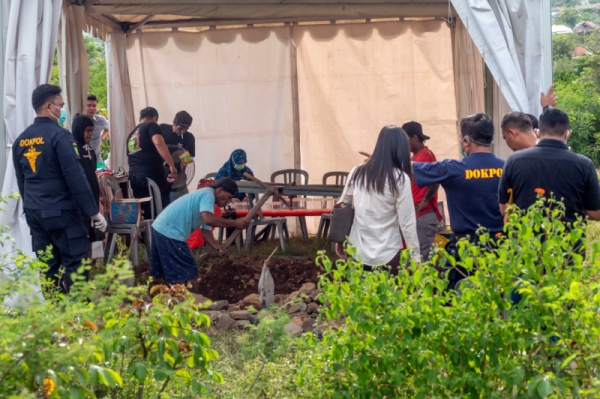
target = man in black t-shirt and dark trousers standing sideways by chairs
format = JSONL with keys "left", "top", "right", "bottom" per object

{"left": 127, "top": 107, "right": 177, "bottom": 218}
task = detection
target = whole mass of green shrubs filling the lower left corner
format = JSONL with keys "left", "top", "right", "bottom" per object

{"left": 0, "top": 203, "right": 222, "bottom": 399}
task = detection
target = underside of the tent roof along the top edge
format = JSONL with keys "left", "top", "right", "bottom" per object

{"left": 76, "top": 0, "right": 453, "bottom": 31}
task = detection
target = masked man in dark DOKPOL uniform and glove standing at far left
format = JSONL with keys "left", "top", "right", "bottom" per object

{"left": 12, "top": 84, "right": 106, "bottom": 292}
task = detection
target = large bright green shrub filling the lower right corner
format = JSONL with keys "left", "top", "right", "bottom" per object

{"left": 299, "top": 201, "right": 600, "bottom": 398}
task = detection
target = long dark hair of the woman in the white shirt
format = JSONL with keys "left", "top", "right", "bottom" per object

{"left": 352, "top": 125, "right": 412, "bottom": 195}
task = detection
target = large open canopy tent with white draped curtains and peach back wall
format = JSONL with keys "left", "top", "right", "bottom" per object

{"left": 0, "top": 0, "right": 552, "bottom": 284}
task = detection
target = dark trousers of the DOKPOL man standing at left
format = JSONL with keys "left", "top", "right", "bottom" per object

{"left": 25, "top": 209, "right": 90, "bottom": 292}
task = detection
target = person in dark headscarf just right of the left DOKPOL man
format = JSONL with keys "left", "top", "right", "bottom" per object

{"left": 71, "top": 114, "right": 100, "bottom": 242}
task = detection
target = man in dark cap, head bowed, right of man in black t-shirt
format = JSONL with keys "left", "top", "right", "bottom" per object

{"left": 160, "top": 111, "right": 196, "bottom": 202}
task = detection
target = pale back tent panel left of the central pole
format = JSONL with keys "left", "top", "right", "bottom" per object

{"left": 127, "top": 27, "right": 294, "bottom": 188}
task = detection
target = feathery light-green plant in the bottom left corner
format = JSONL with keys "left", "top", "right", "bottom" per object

{"left": 0, "top": 254, "right": 134, "bottom": 398}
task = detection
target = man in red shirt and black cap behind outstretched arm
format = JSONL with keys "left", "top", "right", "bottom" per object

{"left": 402, "top": 122, "right": 442, "bottom": 260}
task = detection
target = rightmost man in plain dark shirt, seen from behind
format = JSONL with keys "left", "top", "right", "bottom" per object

{"left": 498, "top": 108, "right": 600, "bottom": 222}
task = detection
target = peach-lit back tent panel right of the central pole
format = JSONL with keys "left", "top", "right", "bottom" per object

{"left": 294, "top": 21, "right": 458, "bottom": 231}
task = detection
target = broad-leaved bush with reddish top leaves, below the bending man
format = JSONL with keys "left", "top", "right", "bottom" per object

{"left": 98, "top": 285, "right": 223, "bottom": 398}
